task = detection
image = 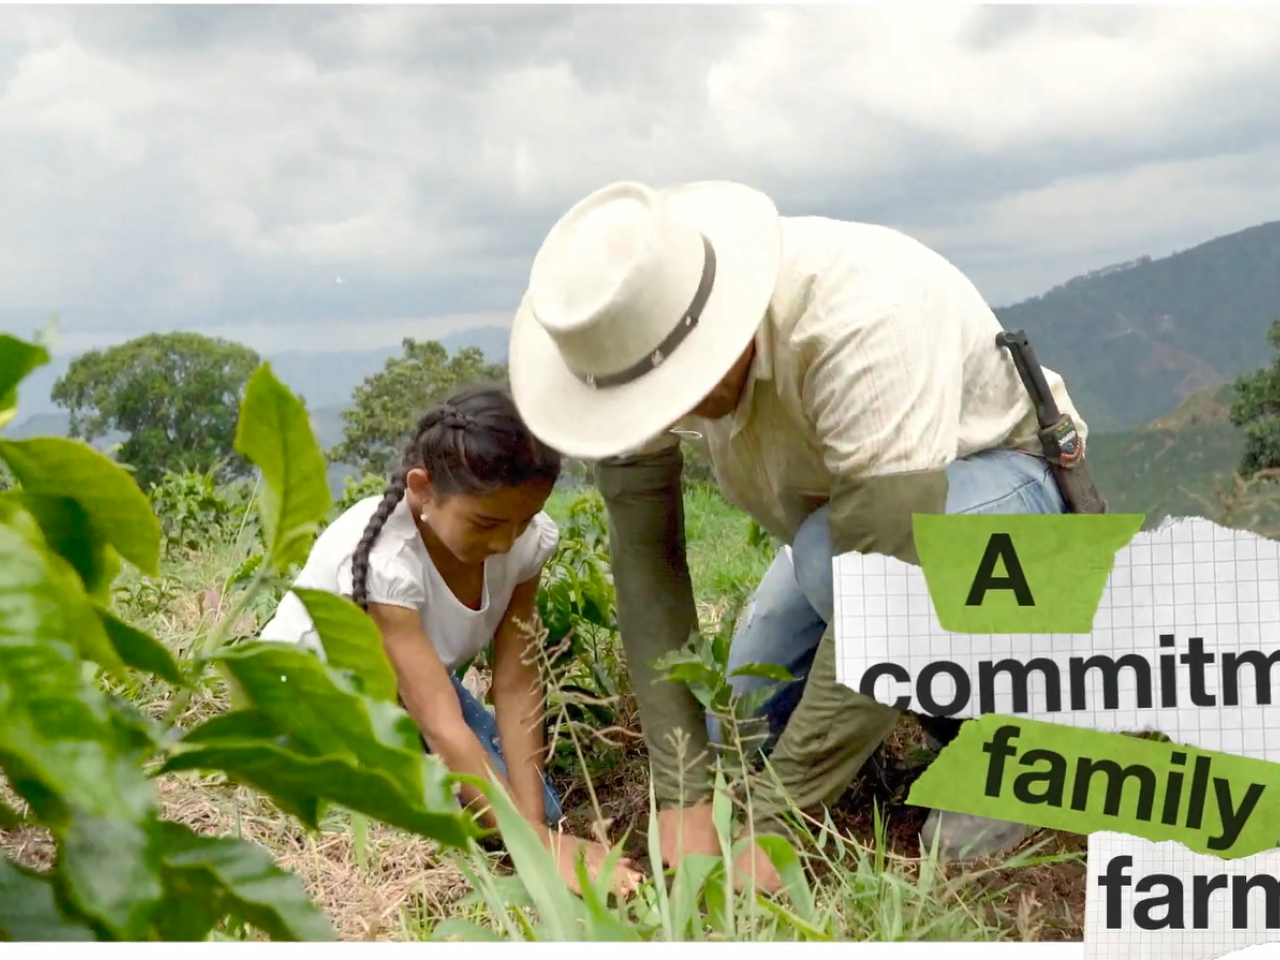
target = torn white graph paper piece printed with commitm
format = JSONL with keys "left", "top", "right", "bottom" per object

{"left": 835, "top": 520, "right": 1280, "bottom": 762}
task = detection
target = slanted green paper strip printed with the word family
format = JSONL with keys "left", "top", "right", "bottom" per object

{"left": 908, "top": 713, "right": 1280, "bottom": 860}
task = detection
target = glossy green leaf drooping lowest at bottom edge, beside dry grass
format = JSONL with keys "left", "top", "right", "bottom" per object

{"left": 149, "top": 823, "right": 337, "bottom": 941}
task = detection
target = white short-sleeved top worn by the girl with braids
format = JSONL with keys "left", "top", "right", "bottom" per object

{"left": 261, "top": 497, "right": 559, "bottom": 672}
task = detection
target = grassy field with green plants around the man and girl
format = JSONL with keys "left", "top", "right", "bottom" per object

{"left": 0, "top": 339, "right": 1084, "bottom": 941}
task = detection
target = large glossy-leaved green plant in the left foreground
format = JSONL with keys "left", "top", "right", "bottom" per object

{"left": 0, "top": 337, "right": 480, "bottom": 941}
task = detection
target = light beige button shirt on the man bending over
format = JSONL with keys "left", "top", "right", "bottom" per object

{"left": 624, "top": 216, "right": 1087, "bottom": 544}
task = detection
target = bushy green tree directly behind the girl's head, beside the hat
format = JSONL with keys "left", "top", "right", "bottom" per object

{"left": 329, "top": 337, "right": 507, "bottom": 476}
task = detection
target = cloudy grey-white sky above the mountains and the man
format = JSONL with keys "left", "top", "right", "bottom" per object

{"left": 0, "top": 4, "right": 1280, "bottom": 352}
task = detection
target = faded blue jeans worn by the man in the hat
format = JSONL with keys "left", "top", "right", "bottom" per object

{"left": 707, "top": 449, "right": 1066, "bottom": 749}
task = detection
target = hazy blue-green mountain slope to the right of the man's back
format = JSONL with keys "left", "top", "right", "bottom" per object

{"left": 996, "top": 223, "right": 1280, "bottom": 431}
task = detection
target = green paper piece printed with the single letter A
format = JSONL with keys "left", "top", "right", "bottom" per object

{"left": 913, "top": 513, "right": 1143, "bottom": 634}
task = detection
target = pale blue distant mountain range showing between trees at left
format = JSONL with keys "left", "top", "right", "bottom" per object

{"left": 18, "top": 326, "right": 511, "bottom": 417}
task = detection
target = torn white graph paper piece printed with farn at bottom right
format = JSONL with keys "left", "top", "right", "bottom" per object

{"left": 1084, "top": 833, "right": 1280, "bottom": 960}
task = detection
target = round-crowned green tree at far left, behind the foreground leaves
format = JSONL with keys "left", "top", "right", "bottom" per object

{"left": 52, "top": 333, "right": 261, "bottom": 489}
